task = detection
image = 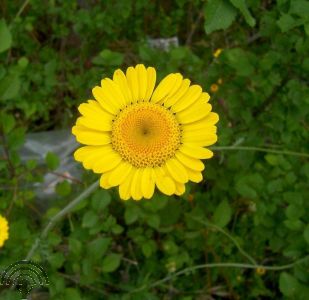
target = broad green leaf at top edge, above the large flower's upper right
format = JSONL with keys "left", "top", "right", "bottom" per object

{"left": 204, "top": 0, "right": 237, "bottom": 34}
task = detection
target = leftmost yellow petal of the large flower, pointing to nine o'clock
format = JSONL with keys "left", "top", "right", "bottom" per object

{"left": 72, "top": 125, "right": 111, "bottom": 146}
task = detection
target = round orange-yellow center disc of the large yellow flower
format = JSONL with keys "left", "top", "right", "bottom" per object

{"left": 112, "top": 102, "right": 181, "bottom": 168}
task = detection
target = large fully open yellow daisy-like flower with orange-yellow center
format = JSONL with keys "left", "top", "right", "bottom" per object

{"left": 72, "top": 64, "right": 219, "bottom": 200}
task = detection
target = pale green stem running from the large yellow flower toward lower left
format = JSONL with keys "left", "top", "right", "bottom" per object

{"left": 26, "top": 181, "right": 99, "bottom": 260}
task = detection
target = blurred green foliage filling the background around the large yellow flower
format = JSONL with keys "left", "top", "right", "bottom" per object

{"left": 0, "top": 0, "right": 309, "bottom": 300}
